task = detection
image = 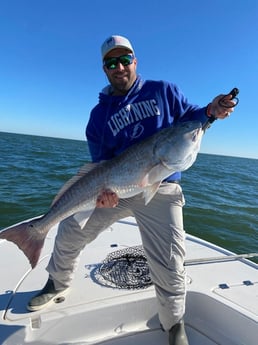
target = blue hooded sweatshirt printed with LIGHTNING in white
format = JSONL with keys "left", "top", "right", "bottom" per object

{"left": 86, "top": 76, "right": 208, "bottom": 181}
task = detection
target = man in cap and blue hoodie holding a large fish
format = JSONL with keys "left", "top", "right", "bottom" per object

{"left": 28, "top": 36, "right": 235, "bottom": 345}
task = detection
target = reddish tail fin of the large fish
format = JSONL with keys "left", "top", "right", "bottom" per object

{"left": 0, "top": 220, "right": 45, "bottom": 268}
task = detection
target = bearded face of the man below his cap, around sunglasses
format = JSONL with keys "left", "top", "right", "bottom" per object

{"left": 103, "top": 48, "right": 137, "bottom": 95}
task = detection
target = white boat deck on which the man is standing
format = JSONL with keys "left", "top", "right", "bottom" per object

{"left": 0, "top": 217, "right": 258, "bottom": 345}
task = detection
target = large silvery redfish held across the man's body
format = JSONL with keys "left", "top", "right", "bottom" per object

{"left": 0, "top": 121, "right": 203, "bottom": 268}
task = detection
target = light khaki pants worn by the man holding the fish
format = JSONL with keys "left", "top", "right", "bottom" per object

{"left": 47, "top": 183, "right": 186, "bottom": 330}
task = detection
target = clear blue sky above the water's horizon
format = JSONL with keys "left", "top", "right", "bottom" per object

{"left": 0, "top": 0, "right": 258, "bottom": 158}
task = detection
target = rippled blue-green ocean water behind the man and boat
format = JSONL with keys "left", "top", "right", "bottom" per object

{"left": 0, "top": 132, "right": 258, "bottom": 262}
